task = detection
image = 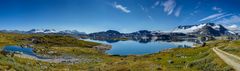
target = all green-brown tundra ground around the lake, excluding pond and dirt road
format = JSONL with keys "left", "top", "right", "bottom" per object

{"left": 0, "top": 33, "right": 235, "bottom": 71}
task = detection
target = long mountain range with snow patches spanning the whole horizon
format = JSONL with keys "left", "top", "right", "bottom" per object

{"left": 0, "top": 23, "right": 237, "bottom": 37}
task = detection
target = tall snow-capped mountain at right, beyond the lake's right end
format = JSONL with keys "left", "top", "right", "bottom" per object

{"left": 172, "top": 23, "right": 235, "bottom": 36}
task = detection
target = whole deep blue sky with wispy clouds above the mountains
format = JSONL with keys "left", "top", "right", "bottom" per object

{"left": 0, "top": 0, "right": 240, "bottom": 33}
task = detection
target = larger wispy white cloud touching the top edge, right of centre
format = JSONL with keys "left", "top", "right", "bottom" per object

{"left": 161, "top": 0, "right": 176, "bottom": 15}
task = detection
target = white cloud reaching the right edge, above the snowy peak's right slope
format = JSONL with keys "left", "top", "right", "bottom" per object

{"left": 216, "top": 15, "right": 240, "bottom": 24}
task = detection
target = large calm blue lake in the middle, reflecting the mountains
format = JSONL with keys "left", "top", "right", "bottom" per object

{"left": 83, "top": 39, "right": 195, "bottom": 55}
